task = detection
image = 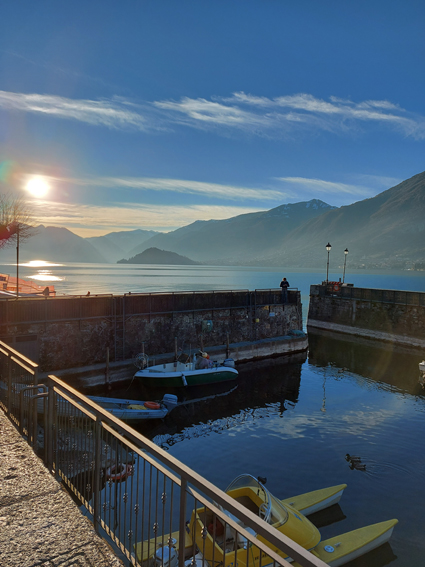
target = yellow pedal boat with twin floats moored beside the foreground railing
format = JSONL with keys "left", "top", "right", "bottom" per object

{"left": 135, "top": 475, "right": 397, "bottom": 567}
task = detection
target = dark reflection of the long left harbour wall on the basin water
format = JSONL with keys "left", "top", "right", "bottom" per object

{"left": 107, "top": 353, "right": 307, "bottom": 449}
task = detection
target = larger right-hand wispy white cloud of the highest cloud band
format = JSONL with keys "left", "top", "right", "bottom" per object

{"left": 155, "top": 92, "right": 425, "bottom": 139}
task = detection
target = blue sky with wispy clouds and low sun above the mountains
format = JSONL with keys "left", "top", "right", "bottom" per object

{"left": 0, "top": 0, "right": 425, "bottom": 237}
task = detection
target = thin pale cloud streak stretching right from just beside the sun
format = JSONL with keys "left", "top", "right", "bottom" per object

{"left": 50, "top": 177, "right": 285, "bottom": 201}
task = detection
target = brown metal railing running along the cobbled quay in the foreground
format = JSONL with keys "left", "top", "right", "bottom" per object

{"left": 0, "top": 342, "right": 325, "bottom": 567}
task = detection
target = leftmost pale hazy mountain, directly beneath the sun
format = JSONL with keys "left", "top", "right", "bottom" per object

{"left": 0, "top": 225, "right": 106, "bottom": 263}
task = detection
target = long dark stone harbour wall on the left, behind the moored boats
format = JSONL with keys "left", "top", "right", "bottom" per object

{"left": 0, "top": 290, "right": 302, "bottom": 372}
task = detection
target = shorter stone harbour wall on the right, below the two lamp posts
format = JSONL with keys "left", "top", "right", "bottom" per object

{"left": 307, "top": 285, "right": 425, "bottom": 346}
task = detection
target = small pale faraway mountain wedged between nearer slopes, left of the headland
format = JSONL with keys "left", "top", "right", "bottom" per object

{"left": 86, "top": 229, "right": 158, "bottom": 262}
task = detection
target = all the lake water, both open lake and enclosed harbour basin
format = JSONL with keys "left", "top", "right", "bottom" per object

{"left": 0, "top": 264, "right": 425, "bottom": 567}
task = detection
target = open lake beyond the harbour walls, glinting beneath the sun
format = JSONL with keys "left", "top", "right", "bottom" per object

{"left": 0, "top": 256, "right": 425, "bottom": 324}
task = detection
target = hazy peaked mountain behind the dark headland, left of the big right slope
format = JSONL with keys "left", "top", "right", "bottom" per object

{"left": 130, "top": 199, "right": 335, "bottom": 264}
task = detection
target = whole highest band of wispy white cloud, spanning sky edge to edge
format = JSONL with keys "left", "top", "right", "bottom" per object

{"left": 0, "top": 91, "right": 425, "bottom": 140}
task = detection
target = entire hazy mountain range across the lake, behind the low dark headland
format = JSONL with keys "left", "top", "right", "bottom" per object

{"left": 0, "top": 172, "right": 425, "bottom": 269}
